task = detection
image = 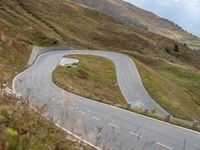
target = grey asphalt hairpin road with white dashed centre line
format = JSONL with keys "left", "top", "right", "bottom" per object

{"left": 13, "top": 50, "right": 200, "bottom": 150}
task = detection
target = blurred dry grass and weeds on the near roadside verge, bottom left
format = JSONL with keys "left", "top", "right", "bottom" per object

{"left": 0, "top": 96, "right": 93, "bottom": 150}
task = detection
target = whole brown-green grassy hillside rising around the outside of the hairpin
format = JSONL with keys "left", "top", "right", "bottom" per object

{"left": 0, "top": 0, "right": 200, "bottom": 120}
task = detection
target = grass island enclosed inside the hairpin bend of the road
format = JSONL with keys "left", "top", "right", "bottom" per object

{"left": 53, "top": 55, "right": 127, "bottom": 107}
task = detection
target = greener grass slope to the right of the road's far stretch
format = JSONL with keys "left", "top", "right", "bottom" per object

{"left": 130, "top": 55, "right": 200, "bottom": 120}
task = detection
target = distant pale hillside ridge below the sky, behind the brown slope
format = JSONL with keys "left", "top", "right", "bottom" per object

{"left": 73, "top": 0, "right": 200, "bottom": 49}
